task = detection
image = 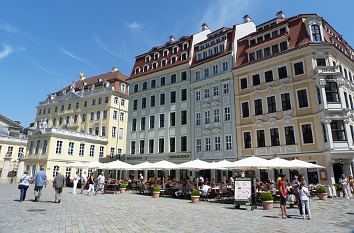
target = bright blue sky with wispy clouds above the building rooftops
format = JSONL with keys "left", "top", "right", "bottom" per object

{"left": 0, "top": 0, "right": 354, "bottom": 126}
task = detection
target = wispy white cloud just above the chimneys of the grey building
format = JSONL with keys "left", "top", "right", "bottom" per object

{"left": 200, "top": 0, "right": 250, "bottom": 30}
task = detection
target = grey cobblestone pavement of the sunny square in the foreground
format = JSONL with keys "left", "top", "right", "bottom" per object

{"left": 0, "top": 185, "right": 354, "bottom": 233}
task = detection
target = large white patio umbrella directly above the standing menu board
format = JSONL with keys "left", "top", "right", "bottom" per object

{"left": 225, "top": 156, "right": 273, "bottom": 170}
